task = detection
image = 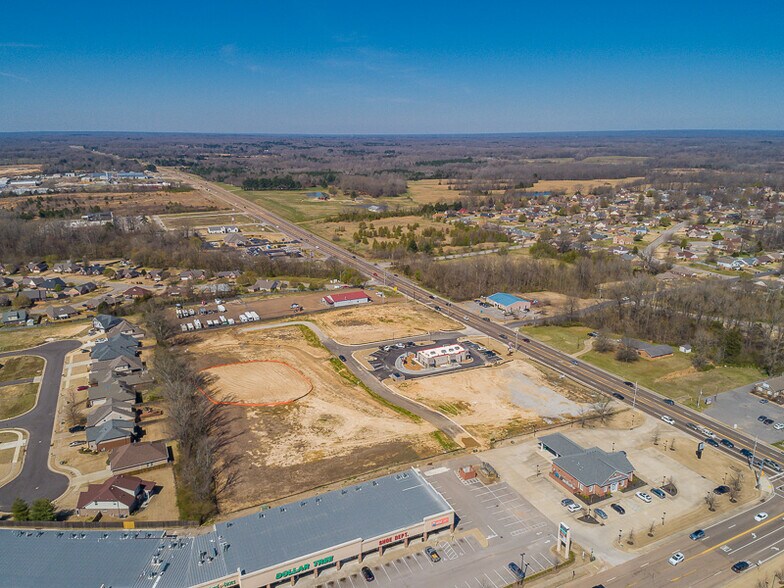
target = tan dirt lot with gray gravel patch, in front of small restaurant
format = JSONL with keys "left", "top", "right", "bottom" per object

{"left": 392, "top": 359, "right": 581, "bottom": 442}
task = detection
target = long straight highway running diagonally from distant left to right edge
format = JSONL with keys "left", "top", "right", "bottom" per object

{"left": 172, "top": 170, "right": 784, "bottom": 474}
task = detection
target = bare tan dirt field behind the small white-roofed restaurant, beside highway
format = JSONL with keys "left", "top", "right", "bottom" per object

{"left": 308, "top": 298, "right": 463, "bottom": 345}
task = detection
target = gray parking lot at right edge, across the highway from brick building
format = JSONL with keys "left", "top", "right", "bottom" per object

{"left": 705, "top": 386, "right": 784, "bottom": 443}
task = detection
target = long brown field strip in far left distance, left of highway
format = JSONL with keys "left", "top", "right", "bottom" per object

{"left": 0, "top": 190, "right": 226, "bottom": 215}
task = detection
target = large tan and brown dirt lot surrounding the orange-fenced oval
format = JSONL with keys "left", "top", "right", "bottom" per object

{"left": 188, "top": 326, "right": 438, "bottom": 512}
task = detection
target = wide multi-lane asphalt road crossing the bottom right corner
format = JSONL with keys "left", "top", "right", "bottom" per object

{"left": 566, "top": 495, "right": 784, "bottom": 588}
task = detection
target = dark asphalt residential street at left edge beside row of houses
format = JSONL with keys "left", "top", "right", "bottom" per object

{"left": 0, "top": 340, "right": 81, "bottom": 511}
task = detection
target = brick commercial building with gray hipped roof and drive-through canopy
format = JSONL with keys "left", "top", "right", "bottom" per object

{"left": 539, "top": 433, "right": 634, "bottom": 496}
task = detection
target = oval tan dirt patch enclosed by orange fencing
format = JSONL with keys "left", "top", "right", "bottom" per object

{"left": 201, "top": 360, "right": 313, "bottom": 405}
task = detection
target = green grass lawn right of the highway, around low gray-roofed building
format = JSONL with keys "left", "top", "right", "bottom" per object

{"left": 581, "top": 351, "right": 765, "bottom": 408}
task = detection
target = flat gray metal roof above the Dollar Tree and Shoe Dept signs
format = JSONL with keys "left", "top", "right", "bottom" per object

{"left": 216, "top": 469, "right": 452, "bottom": 572}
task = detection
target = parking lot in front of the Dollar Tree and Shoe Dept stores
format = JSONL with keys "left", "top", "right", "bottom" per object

{"left": 298, "top": 458, "right": 556, "bottom": 588}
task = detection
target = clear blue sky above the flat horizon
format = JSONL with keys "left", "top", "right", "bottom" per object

{"left": 0, "top": 0, "right": 784, "bottom": 133}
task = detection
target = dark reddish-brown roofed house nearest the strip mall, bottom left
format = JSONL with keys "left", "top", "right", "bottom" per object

{"left": 76, "top": 474, "right": 155, "bottom": 517}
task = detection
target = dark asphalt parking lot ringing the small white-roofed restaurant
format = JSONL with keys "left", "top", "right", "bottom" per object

{"left": 367, "top": 338, "right": 500, "bottom": 380}
